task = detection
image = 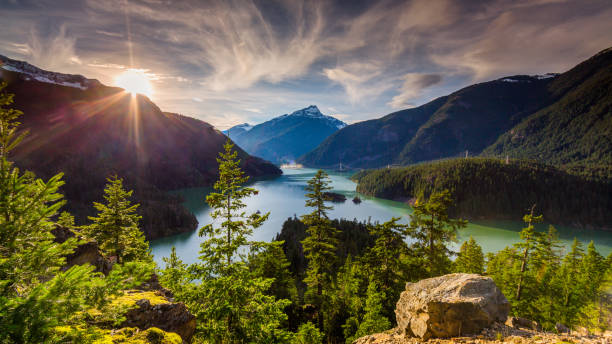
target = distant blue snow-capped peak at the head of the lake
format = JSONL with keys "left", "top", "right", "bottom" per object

{"left": 228, "top": 105, "right": 346, "bottom": 163}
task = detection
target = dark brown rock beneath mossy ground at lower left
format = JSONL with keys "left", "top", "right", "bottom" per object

{"left": 121, "top": 299, "right": 196, "bottom": 343}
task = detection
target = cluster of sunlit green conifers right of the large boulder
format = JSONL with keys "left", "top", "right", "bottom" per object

{"left": 487, "top": 207, "right": 609, "bottom": 330}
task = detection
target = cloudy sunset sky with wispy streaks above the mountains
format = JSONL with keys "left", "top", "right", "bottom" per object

{"left": 0, "top": 0, "right": 612, "bottom": 129}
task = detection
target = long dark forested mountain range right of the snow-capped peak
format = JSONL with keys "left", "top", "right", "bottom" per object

{"left": 299, "top": 49, "right": 612, "bottom": 168}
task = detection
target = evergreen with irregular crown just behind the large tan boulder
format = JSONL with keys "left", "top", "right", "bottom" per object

{"left": 409, "top": 190, "right": 467, "bottom": 277}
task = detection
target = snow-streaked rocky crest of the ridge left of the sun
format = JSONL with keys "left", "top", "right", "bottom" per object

{"left": 0, "top": 55, "right": 100, "bottom": 90}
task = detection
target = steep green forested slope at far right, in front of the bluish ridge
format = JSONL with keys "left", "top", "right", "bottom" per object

{"left": 483, "top": 49, "right": 612, "bottom": 166}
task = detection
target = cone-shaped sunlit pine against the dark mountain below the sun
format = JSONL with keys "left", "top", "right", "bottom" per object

{"left": 87, "top": 176, "right": 152, "bottom": 263}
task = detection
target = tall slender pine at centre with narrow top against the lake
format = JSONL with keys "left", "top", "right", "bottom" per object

{"left": 302, "top": 170, "right": 338, "bottom": 329}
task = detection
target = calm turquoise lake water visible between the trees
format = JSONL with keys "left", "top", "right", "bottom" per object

{"left": 151, "top": 168, "right": 612, "bottom": 266}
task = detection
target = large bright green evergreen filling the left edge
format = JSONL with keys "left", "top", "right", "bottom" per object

{"left": 0, "top": 84, "right": 150, "bottom": 343}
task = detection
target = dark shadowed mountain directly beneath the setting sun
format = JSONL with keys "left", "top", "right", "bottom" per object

{"left": 0, "top": 56, "right": 281, "bottom": 239}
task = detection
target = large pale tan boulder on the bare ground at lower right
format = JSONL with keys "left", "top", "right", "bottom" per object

{"left": 395, "top": 274, "right": 510, "bottom": 340}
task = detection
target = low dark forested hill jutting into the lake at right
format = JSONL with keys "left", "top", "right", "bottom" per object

{"left": 353, "top": 158, "right": 612, "bottom": 230}
